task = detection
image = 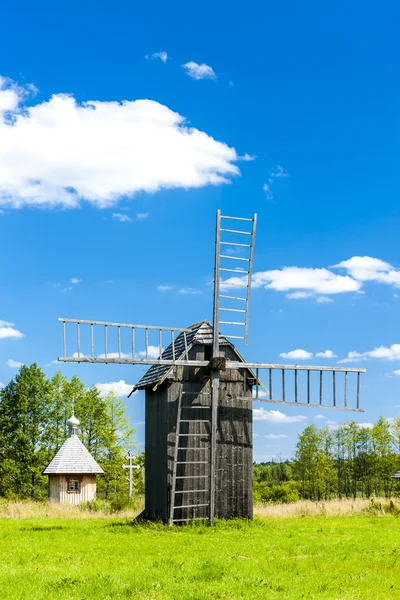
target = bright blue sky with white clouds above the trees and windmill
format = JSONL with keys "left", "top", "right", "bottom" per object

{"left": 0, "top": 1, "right": 400, "bottom": 459}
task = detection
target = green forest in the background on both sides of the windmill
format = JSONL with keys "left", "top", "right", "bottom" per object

{"left": 0, "top": 364, "right": 400, "bottom": 503}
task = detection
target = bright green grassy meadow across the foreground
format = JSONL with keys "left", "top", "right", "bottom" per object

{"left": 0, "top": 501, "right": 400, "bottom": 600}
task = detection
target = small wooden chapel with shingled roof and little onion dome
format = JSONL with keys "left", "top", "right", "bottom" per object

{"left": 42, "top": 415, "right": 104, "bottom": 505}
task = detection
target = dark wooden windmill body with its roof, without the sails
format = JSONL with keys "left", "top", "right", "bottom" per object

{"left": 134, "top": 321, "right": 255, "bottom": 522}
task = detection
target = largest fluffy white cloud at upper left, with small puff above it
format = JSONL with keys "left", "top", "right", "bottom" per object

{"left": 0, "top": 75, "right": 240, "bottom": 208}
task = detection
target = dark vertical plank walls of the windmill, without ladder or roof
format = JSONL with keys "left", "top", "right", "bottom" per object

{"left": 145, "top": 345, "right": 253, "bottom": 520}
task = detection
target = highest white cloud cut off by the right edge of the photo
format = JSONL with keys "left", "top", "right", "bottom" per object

{"left": 334, "top": 256, "right": 400, "bottom": 287}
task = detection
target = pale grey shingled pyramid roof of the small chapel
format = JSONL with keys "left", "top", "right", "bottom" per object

{"left": 43, "top": 435, "right": 104, "bottom": 475}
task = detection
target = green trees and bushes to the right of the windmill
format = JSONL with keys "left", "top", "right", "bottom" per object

{"left": 253, "top": 416, "right": 400, "bottom": 502}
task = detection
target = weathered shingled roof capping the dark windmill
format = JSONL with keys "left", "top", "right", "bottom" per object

{"left": 131, "top": 321, "right": 255, "bottom": 393}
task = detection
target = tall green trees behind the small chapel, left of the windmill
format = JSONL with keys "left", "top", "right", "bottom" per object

{"left": 0, "top": 364, "right": 142, "bottom": 500}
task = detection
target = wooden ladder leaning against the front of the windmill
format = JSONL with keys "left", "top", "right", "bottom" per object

{"left": 169, "top": 392, "right": 211, "bottom": 525}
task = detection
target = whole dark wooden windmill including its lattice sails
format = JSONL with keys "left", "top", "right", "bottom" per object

{"left": 58, "top": 211, "right": 365, "bottom": 524}
